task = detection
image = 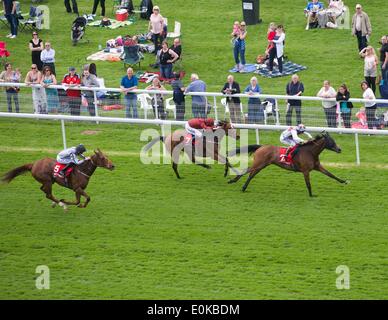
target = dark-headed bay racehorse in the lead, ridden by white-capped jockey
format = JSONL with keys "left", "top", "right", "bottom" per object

{"left": 228, "top": 131, "right": 349, "bottom": 197}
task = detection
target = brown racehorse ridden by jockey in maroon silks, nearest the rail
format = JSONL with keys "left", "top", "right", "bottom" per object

{"left": 143, "top": 121, "right": 240, "bottom": 179}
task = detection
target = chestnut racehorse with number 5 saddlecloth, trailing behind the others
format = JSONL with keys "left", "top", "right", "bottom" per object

{"left": 1, "top": 149, "right": 115, "bottom": 211}
